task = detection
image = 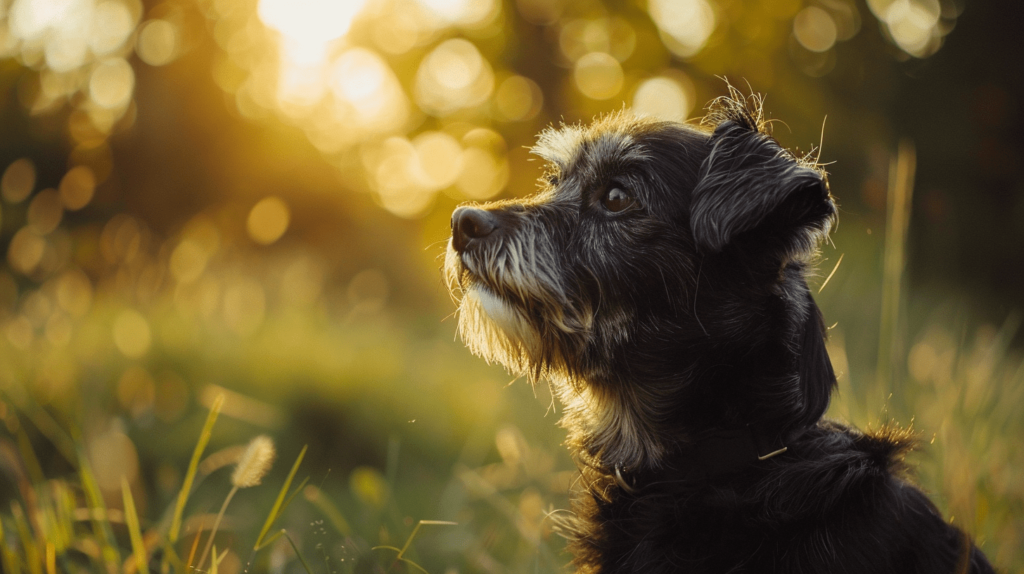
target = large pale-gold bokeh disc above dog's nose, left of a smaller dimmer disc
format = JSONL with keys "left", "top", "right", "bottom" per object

{"left": 415, "top": 38, "right": 495, "bottom": 117}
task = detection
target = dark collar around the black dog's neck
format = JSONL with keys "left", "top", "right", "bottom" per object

{"left": 614, "top": 425, "right": 810, "bottom": 493}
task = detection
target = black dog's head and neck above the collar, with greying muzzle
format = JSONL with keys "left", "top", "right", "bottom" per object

{"left": 445, "top": 87, "right": 836, "bottom": 468}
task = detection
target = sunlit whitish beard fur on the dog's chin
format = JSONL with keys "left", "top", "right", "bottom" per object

{"left": 459, "top": 283, "right": 541, "bottom": 380}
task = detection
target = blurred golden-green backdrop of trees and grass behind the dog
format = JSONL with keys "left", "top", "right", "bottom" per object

{"left": 0, "top": 0, "right": 1024, "bottom": 574}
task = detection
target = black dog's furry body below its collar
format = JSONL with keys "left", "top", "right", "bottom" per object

{"left": 563, "top": 422, "right": 992, "bottom": 574}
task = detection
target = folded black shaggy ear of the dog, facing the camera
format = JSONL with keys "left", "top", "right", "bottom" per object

{"left": 690, "top": 119, "right": 836, "bottom": 253}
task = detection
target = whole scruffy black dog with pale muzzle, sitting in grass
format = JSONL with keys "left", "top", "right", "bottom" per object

{"left": 445, "top": 90, "right": 992, "bottom": 574}
